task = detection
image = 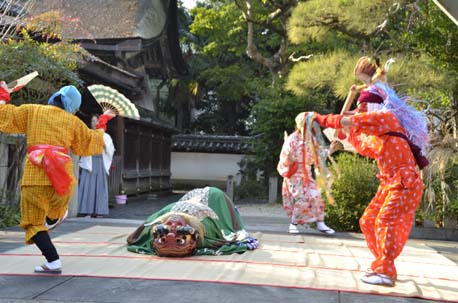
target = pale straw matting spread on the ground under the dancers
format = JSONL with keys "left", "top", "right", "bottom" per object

{"left": 0, "top": 226, "right": 458, "bottom": 302}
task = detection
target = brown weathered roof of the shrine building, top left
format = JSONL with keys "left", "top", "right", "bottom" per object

{"left": 28, "top": 0, "right": 169, "bottom": 40}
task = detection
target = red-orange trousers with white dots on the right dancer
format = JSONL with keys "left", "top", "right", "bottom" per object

{"left": 359, "top": 176, "right": 423, "bottom": 279}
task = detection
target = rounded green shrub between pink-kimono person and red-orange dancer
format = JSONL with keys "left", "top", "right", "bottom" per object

{"left": 326, "top": 153, "right": 379, "bottom": 232}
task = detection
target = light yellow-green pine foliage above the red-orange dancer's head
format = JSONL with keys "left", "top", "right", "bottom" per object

{"left": 286, "top": 0, "right": 457, "bottom": 99}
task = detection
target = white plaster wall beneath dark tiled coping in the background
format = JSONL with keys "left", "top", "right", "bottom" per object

{"left": 170, "top": 152, "right": 243, "bottom": 181}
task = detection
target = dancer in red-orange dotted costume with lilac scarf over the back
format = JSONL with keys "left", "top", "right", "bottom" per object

{"left": 315, "top": 57, "right": 429, "bottom": 286}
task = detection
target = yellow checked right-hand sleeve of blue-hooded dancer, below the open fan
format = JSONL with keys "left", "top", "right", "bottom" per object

{"left": 71, "top": 118, "right": 104, "bottom": 156}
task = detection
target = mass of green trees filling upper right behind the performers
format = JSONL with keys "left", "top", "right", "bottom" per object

{"left": 185, "top": 0, "right": 458, "bottom": 176}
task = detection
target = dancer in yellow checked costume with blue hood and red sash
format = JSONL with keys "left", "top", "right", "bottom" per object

{"left": 0, "top": 81, "right": 112, "bottom": 273}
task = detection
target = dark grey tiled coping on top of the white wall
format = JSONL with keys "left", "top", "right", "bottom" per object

{"left": 172, "top": 135, "right": 251, "bottom": 154}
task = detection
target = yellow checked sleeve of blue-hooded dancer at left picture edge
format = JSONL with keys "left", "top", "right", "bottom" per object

{"left": 0, "top": 104, "right": 29, "bottom": 134}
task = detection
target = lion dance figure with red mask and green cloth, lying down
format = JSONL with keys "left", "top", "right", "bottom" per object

{"left": 127, "top": 187, "right": 258, "bottom": 257}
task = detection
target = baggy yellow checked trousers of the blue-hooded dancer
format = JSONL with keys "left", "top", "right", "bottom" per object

{"left": 21, "top": 185, "right": 74, "bottom": 244}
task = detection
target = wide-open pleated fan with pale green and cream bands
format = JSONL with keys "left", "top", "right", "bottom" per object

{"left": 87, "top": 84, "right": 140, "bottom": 120}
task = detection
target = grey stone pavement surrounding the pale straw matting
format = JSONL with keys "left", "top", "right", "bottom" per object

{"left": 0, "top": 194, "right": 458, "bottom": 303}
